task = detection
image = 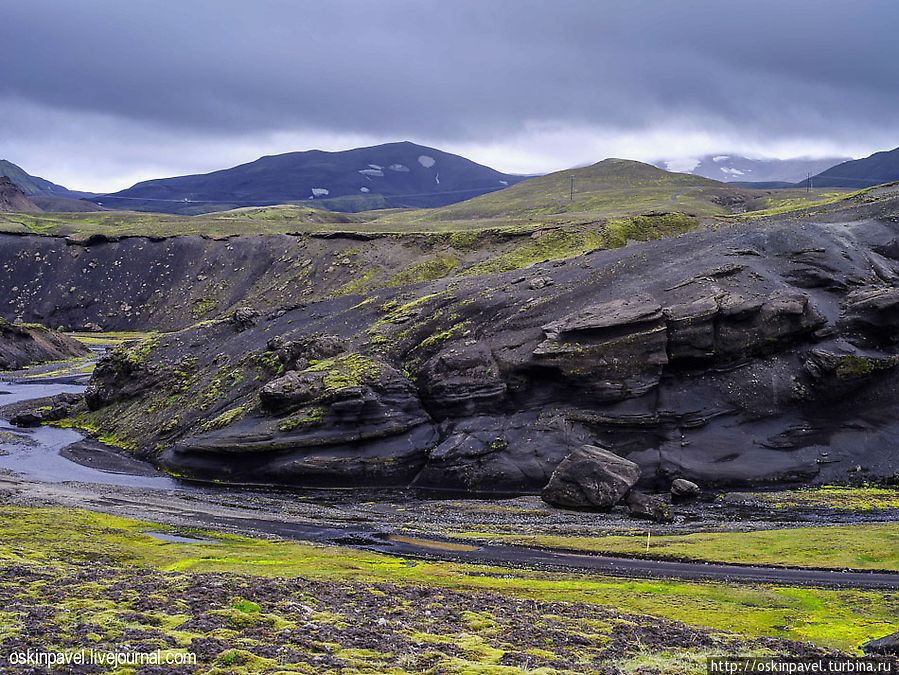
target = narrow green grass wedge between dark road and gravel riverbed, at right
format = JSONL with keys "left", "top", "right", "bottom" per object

{"left": 458, "top": 522, "right": 899, "bottom": 572}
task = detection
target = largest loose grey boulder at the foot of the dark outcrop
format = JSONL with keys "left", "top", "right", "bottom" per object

{"left": 540, "top": 445, "right": 640, "bottom": 509}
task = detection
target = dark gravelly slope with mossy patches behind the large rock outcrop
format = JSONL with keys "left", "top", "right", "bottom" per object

{"left": 0, "top": 228, "right": 598, "bottom": 331}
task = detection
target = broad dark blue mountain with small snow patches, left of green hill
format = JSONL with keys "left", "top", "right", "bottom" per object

{"left": 95, "top": 142, "right": 524, "bottom": 214}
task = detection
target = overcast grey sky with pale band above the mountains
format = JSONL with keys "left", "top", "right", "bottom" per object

{"left": 0, "top": 0, "right": 899, "bottom": 191}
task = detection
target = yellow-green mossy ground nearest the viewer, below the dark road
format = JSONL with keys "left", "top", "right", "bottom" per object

{"left": 0, "top": 506, "right": 899, "bottom": 673}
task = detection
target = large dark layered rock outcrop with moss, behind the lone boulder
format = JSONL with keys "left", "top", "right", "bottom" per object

{"left": 74, "top": 206, "right": 899, "bottom": 492}
